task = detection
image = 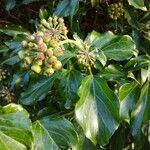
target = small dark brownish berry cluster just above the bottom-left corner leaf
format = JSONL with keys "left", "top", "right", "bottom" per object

{"left": 0, "top": 86, "right": 15, "bottom": 102}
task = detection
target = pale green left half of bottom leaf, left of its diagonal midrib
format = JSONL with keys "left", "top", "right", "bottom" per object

{"left": 32, "top": 121, "right": 59, "bottom": 150}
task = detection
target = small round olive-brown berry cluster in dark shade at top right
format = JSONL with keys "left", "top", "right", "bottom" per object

{"left": 108, "top": 2, "right": 124, "bottom": 20}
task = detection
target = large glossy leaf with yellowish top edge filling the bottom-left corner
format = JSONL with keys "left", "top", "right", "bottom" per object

{"left": 0, "top": 104, "right": 32, "bottom": 150}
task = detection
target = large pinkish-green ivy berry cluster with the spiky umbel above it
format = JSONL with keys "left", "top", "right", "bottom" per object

{"left": 18, "top": 17, "right": 67, "bottom": 76}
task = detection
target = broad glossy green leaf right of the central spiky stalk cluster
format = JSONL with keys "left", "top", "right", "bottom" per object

{"left": 93, "top": 31, "right": 137, "bottom": 61}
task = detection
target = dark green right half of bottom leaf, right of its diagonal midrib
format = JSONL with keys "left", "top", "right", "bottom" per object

{"left": 40, "top": 116, "right": 78, "bottom": 149}
